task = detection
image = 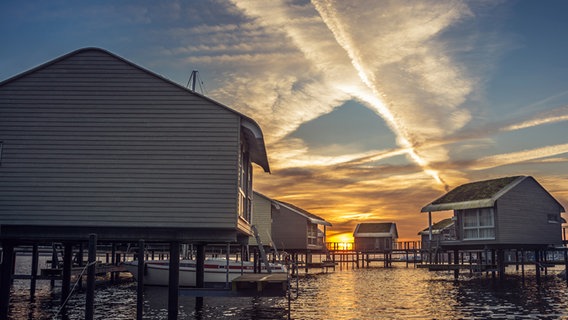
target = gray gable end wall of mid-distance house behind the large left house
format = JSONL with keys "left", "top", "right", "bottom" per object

{"left": 272, "top": 206, "right": 308, "bottom": 250}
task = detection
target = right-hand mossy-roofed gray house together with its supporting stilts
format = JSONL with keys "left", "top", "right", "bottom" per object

{"left": 421, "top": 176, "right": 565, "bottom": 280}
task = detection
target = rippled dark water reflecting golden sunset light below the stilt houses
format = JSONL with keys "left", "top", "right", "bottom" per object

{"left": 11, "top": 257, "right": 568, "bottom": 320}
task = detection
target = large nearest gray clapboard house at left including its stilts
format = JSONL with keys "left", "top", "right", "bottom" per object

{"left": 0, "top": 48, "right": 270, "bottom": 319}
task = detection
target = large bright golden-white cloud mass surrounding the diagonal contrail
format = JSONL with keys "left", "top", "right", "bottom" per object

{"left": 223, "top": 0, "right": 496, "bottom": 190}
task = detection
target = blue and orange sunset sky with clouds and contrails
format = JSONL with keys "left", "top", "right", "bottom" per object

{"left": 0, "top": 0, "right": 568, "bottom": 241}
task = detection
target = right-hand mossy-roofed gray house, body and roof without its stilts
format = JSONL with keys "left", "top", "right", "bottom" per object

{"left": 422, "top": 176, "right": 564, "bottom": 248}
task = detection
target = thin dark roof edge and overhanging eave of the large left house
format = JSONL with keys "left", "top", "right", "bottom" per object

{"left": 0, "top": 47, "right": 270, "bottom": 172}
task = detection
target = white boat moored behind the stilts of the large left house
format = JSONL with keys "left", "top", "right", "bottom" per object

{"left": 123, "top": 259, "right": 287, "bottom": 287}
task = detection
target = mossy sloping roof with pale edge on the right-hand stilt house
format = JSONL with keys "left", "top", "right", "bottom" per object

{"left": 421, "top": 176, "right": 532, "bottom": 212}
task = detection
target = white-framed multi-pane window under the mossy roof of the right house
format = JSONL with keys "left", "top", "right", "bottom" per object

{"left": 463, "top": 208, "right": 495, "bottom": 240}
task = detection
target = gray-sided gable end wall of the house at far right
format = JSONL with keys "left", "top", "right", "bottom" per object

{"left": 495, "top": 179, "right": 562, "bottom": 245}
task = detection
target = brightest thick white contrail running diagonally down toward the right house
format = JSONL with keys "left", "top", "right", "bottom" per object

{"left": 312, "top": 0, "right": 448, "bottom": 189}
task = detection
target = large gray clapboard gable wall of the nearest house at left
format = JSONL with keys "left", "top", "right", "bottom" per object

{"left": 0, "top": 51, "right": 240, "bottom": 229}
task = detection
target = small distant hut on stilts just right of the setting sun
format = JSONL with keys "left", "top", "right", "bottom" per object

{"left": 353, "top": 222, "right": 398, "bottom": 252}
